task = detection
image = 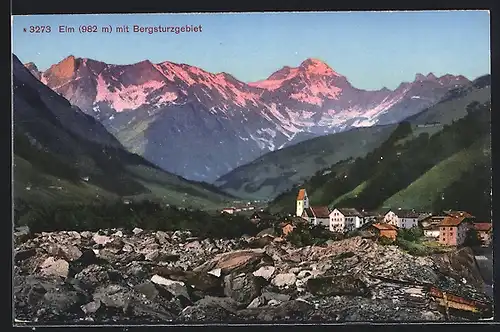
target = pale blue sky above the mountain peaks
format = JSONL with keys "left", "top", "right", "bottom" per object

{"left": 12, "top": 11, "right": 490, "bottom": 90}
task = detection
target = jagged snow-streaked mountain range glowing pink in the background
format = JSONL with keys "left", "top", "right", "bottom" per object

{"left": 25, "top": 56, "right": 470, "bottom": 183}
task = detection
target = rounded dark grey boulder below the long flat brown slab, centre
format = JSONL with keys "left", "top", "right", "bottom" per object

{"left": 224, "top": 274, "right": 262, "bottom": 305}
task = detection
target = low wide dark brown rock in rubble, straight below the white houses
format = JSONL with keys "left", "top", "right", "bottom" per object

{"left": 306, "top": 275, "right": 368, "bottom": 296}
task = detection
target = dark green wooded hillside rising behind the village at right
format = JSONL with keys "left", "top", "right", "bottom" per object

{"left": 270, "top": 95, "right": 491, "bottom": 220}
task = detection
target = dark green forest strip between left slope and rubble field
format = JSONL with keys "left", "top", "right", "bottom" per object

{"left": 14, "top": 200, "right": 260, "bottom": 238}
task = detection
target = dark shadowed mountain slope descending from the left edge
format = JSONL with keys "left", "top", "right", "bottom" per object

{"left": 13, "top": 55, "right": 233, "bottom": 209}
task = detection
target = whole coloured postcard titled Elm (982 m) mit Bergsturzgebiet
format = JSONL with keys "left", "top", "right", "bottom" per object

{"left": 12, "top": 10, "right": 494, "bottom": 325}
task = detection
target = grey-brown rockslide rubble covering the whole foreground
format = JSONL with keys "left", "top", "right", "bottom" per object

{"left": 14, "top": 229, "right": 491, "bottom": 324}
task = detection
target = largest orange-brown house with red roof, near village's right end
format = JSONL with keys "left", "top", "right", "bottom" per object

{"left": 438, "top": 211, "right": 475, "bottom": 246}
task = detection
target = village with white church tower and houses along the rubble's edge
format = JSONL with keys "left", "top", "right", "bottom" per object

{"left": 221, "top": 189, "right": 492, "bottom": 247}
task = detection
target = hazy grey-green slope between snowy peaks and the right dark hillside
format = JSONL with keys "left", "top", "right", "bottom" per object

{"left": 214, "top": 76, "right": 491, "bottom": 199}
